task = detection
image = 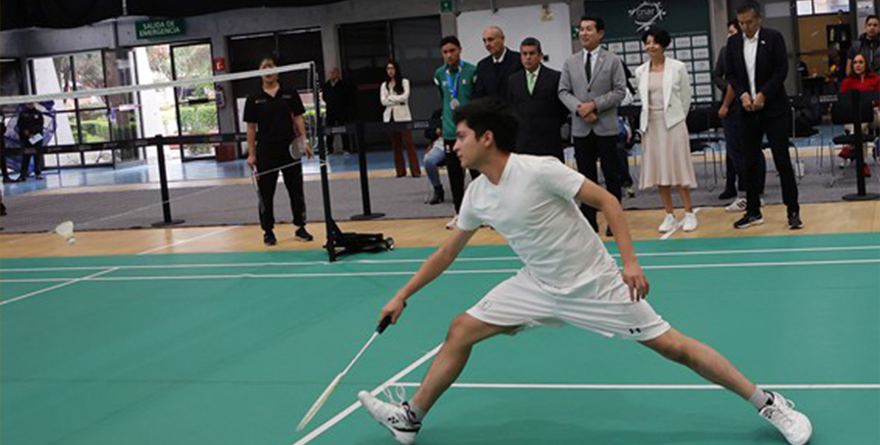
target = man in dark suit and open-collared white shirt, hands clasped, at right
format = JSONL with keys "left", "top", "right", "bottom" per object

{"left": 727, "top": 3, "right": 803, "bottom": 230}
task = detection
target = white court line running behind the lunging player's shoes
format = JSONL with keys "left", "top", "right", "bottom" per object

{"left": 397, "top": 382, "right": 880, "bottom": 390}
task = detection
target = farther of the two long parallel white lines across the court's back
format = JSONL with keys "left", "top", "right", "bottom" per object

{"left": 0, "top": 243, "right": 880, "bottom": 273}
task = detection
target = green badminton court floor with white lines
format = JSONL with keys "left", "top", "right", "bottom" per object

{"left": 0, "top": 233, "right": 880, "bottom": 445}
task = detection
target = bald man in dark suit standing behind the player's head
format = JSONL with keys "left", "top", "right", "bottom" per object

{"left": 473, "top": 26, "right": 522, "bottom": 100}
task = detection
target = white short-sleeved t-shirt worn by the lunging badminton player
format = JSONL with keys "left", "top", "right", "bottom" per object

{"left": 458, "top": 154, "right": 620, "bottom": 294}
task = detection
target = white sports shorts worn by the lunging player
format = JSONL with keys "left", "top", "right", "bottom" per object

{"left": 467, "top": 270, "right": 670, "bottom": 341}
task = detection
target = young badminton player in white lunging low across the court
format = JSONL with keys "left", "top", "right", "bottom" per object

{"left": 358, "top": 99, "right": 812, "bottom": 444}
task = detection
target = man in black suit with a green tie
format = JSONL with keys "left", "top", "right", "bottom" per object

{"left": 507, "top": 37, "right": 568, "bottom": 162}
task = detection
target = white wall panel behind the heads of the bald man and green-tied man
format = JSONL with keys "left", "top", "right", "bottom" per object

{"left": 456, "top": 3, "right": 572, "bottom": 70}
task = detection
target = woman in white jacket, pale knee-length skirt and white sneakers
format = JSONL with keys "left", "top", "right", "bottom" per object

{"left": 635, "top": 27, "right": 697, "bottom": 232}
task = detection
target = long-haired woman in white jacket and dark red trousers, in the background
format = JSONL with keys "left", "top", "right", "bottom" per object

{"left": 379, "top": 60, "right": 422, "bottom": 178}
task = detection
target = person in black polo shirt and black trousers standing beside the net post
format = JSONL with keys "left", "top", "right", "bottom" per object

{"left": 244, "top": 58, "right": 314, "bottom": 246}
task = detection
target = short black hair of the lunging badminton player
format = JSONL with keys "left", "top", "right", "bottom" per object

{"left": 453, "top": 97, "right": 519, "bottom": 153}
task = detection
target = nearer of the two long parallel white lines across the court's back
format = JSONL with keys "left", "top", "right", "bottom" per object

{"left": 0, "top": 259, "right": 880, "bottom": 283}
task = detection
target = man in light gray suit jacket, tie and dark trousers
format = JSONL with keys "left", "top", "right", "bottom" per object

{"left": 559, "top": 16, "right": 626, "bottom": 236}
